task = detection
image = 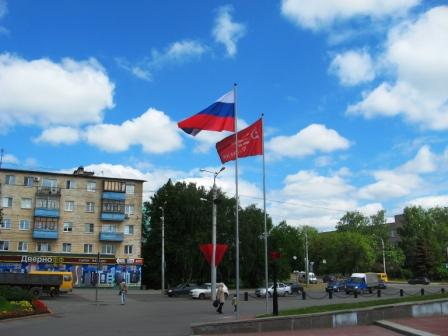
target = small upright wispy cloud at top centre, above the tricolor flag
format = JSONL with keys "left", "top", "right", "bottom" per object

{"left": 213, "top": 6, "right": 246, "bottom": 57}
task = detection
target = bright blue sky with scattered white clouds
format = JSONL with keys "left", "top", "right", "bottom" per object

{"left": 0, "top": 0, "right": 448, "bottom": 231}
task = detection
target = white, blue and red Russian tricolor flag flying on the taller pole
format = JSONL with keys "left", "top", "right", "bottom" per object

{"left": 177, "top": 90, "right": 235, "bottom": 136}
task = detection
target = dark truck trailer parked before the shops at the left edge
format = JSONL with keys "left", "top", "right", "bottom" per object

{"left": 0, "top": 272, "right": 62, "bottom": 298}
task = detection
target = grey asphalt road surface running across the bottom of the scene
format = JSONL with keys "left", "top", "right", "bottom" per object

{"left": 0, "top": 284, "right": 448, "bottom": 336}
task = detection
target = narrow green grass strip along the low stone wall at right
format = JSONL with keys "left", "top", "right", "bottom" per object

{"left": 257, "top": 293, "right": 448, "bottom": 317}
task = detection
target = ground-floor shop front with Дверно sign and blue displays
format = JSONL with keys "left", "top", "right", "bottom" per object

{"left": 0, "top": 252, "right": 143, "bottom": 288}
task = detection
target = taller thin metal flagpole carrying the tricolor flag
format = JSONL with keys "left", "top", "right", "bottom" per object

{"left": 233, "top": 83, "right": 240, "bottom": 320}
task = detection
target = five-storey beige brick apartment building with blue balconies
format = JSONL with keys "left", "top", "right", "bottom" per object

{"left": 0, "top": 167, "right": 144, "bottom": 287}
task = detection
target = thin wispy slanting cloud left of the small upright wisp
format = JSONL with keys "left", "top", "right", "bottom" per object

{"left": 116, "top": 40, "right": 208, "bottom": 81}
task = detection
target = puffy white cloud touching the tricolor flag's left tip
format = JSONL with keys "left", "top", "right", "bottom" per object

{"left": 84, "top": 108, "right": 182, "bottom": 154}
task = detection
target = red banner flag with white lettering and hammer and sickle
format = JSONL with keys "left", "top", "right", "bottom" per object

{"left": 216, "top": 119, "right": 263, "bottom": 163}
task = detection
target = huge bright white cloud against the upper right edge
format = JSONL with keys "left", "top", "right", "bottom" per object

{"left": 347, "top": 7, "right": 448, "bottom": 130}
